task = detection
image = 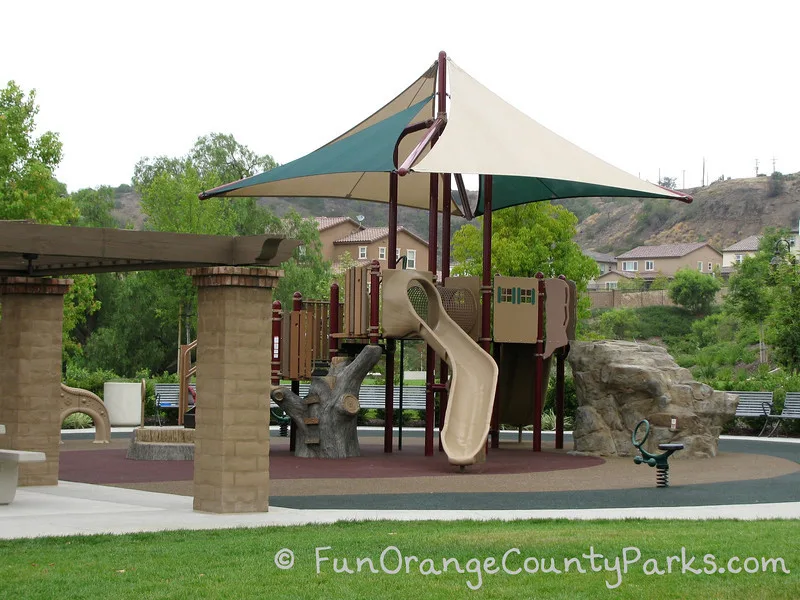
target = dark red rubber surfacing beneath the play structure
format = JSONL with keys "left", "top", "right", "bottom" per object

{"left": 59, "top": 444, "right": 604, "bottom": 484}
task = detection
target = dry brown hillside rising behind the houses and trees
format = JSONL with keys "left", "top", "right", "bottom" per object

{"left": 114, "top": 173, "right": 800, "bottom": 254}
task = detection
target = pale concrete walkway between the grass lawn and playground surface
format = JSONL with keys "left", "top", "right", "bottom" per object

{"left": 0, "top": 438, "right": 800, "bottom": 539}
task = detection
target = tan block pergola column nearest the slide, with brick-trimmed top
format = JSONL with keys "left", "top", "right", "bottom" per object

{"left": 189, "top": 267, "right": 282, "bottom": 513}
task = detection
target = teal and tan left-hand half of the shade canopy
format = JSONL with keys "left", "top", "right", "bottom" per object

{"left": 201, "top": 65, "right": 461, "bottom": 214}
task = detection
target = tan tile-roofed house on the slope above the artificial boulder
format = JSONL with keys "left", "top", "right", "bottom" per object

{"left": 597, "top": 242, "right": 722, "bottom": 289}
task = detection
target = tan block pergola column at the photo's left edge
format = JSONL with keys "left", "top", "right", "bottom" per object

{"left": 0, "top": 277, "right": 72, "bottom": 485}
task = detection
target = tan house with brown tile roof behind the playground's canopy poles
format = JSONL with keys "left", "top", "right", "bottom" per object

{"left": 316, "top": 217, "right": 428, "bottom": 270}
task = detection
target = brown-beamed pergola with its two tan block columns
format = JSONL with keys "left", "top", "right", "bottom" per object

{"left": 0, "top": 221, "right": 299, "bottom": 512}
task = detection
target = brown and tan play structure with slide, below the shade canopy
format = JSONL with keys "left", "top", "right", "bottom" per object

{"left": 272, "top": 261, "right": 576, "bottom": 466}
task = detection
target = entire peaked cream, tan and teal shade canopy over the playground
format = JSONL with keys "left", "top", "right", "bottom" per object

{"left": 200, "top": 59, "right": 691, "bottom": 220}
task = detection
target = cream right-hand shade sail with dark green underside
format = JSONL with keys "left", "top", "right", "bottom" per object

{"left": 413, "top": 59, "right": 691, "bottom": 214}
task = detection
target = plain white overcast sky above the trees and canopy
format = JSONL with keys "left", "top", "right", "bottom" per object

{"left": 0, "top": 0, "right": 800, "bottom": 191}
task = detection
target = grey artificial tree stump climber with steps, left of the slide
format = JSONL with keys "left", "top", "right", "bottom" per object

{"left": 272, "top": 346, "right": 382, "bottom": 458}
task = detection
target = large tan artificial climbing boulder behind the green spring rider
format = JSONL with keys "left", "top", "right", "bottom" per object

{"left": 569, "top": 341, "right": 737, "bottom": 458}
